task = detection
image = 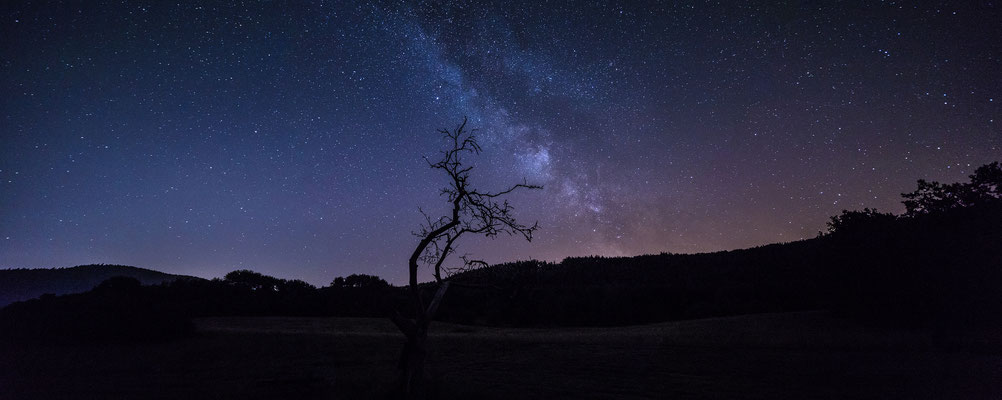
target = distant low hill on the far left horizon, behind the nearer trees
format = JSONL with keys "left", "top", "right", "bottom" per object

{"left": 0, "top": 264, "right": 196, "bottom": 307}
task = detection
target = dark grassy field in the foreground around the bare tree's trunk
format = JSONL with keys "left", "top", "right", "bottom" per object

{"left": 0, "top": 313, "right": 1002, "bottom": 399}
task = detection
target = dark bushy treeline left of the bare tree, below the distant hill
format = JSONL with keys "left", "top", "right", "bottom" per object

{"left": 0, "top": 270, "right": 402, "bottom": 343}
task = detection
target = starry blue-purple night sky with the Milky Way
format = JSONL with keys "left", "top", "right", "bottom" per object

{"left": 0, "top": 0, "right": 1002, "bottom": 285}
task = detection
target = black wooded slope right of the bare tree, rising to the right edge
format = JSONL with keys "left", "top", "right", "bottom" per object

{"left": 440, "top": 162, "right": 1002, "bottom": 328}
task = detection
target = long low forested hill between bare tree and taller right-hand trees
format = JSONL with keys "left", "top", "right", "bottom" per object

{"left": 440, "top": 241, "right": 830, "bottom": 326}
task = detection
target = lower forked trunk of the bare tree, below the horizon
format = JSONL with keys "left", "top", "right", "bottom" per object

{"left": 392, "top": 282, "right": 449, "bottom": 399}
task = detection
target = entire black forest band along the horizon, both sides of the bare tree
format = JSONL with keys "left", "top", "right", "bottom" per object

{"left": 0, "top": 162, "right": 1002, "bottom": 343}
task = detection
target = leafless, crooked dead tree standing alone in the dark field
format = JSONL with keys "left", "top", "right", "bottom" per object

{"left": 393, "top": 118, "right": 542, "bottom": 397}
